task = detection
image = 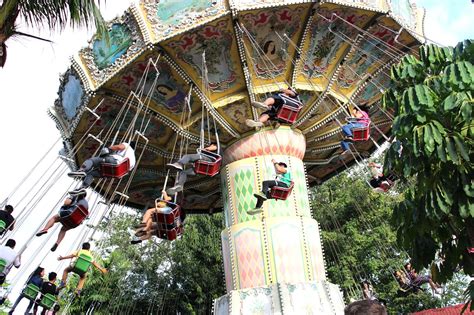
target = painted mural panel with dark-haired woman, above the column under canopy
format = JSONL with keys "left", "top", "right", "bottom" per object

{"left": 241, "top": 6, "right": 307, "bottom": 80}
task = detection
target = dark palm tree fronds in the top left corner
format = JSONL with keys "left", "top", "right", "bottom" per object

{"left": 0, "top": 0, "right": 107, "bottom": 67}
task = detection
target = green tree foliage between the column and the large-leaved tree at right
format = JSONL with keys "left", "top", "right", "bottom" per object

{"left": 312, "top": 174, "right": 440, "bottom": 314}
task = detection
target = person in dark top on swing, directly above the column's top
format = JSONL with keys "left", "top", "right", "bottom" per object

{"left": 245, "top": 87, "right": 301, "bottom": 127}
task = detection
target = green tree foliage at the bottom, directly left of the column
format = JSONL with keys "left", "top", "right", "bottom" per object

{"left": 65, "top": 214, "right": 225, "bottom": 314}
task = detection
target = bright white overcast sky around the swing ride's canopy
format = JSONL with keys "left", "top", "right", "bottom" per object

{"left": 0, "top": 0, "right": 474, "bottom": 312}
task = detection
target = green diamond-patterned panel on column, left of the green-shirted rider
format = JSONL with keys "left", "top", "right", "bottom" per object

{"left": 231, "top": 167, "right": 257, "bottom": 223}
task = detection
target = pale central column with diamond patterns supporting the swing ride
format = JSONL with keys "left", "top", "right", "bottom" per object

{"left": 214, "top": 127, "right": 344, "bottom": 314}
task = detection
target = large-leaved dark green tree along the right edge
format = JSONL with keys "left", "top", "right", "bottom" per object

{"left": 383, "top": 40, "right": 474, "bottom": 288}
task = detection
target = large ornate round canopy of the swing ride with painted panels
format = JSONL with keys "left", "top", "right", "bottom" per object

{"left": 50, "top": 0, "right": 424, "bottom": 212}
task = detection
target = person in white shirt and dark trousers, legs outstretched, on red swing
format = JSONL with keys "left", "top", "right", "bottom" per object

{"left": 68, "top": 141, "right": 136, "bottom": 195}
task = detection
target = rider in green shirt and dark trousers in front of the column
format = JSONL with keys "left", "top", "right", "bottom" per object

{"left": 247, "top": 159, "right": 291, "bottom": 215}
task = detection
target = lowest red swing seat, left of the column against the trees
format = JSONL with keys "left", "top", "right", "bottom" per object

{"left": 153, "top": 201, "right": 183, "bottom": 241}
